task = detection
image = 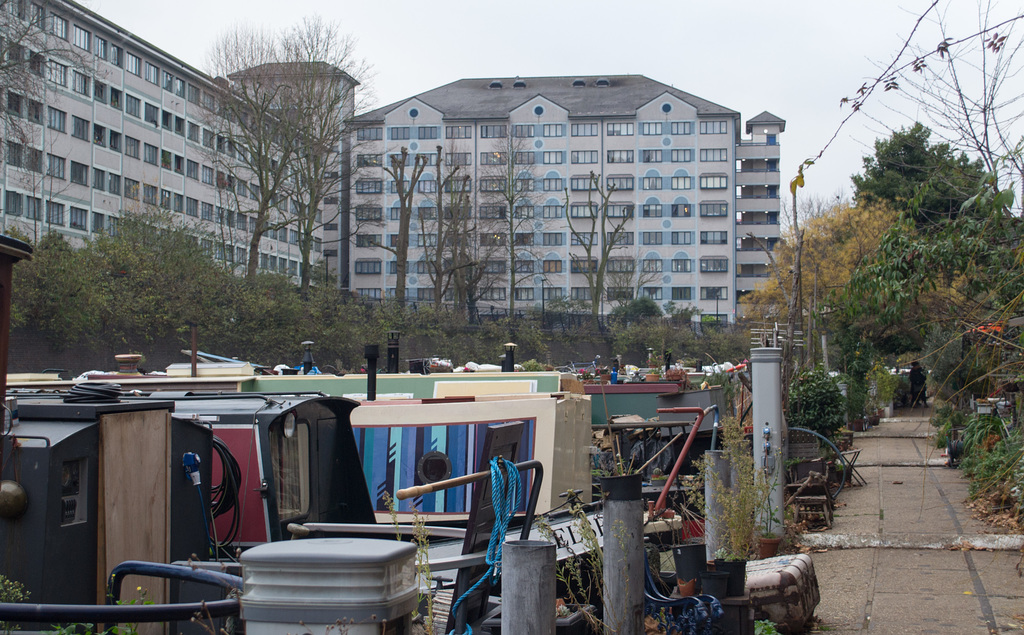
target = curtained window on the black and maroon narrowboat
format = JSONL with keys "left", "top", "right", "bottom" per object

{"left": 269, "top": 417, "right": 309, "bottom": 520}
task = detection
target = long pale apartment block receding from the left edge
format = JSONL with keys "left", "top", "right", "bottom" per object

{"left": 0, "top": 0, "right": 355, "bottom": 276}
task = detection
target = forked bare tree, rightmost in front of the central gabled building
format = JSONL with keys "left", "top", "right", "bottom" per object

{"left": 565, "top": 172, "right": 635, "bottom": 321}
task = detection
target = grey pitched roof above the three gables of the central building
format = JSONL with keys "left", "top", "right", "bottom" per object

{"left": 356, "top": 75, "right": 739, "bottom": 123}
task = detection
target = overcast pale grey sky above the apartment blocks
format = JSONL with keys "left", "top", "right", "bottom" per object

{"left": 85, "top": 0, "right": 1024, "bottom": 203}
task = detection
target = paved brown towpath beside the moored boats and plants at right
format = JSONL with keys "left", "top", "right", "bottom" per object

{"left": 802, "top": 409, "right": 1024, "bottom": 634}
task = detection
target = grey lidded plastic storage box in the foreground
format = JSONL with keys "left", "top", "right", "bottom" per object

{"left": 241, "top": 538, "right": 419, "bottom": 635}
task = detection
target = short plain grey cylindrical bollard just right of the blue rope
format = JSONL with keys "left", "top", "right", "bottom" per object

{"left": 502, "top": 540, "right": 555, "bottom": 635}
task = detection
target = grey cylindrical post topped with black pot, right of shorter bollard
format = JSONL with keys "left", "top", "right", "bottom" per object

{"left": 601, "top": 474, "right": 645, "bottom": 635}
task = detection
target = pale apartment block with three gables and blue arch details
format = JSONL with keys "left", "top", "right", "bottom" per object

{"left": 343, "top": 76, "right": 785, "bottom": 322}
